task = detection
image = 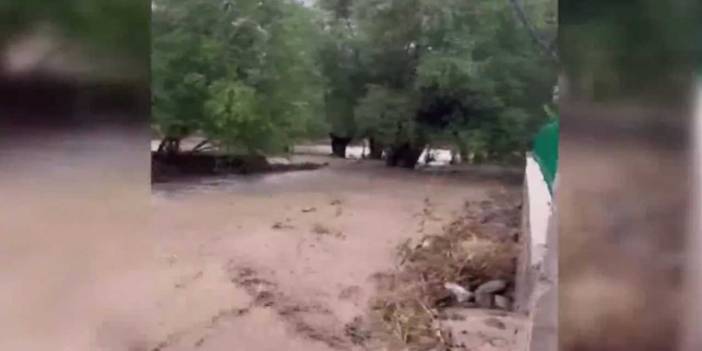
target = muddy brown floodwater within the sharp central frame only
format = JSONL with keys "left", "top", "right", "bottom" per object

{"left": 144, "top": 157, "right": 514, "bottom": 351}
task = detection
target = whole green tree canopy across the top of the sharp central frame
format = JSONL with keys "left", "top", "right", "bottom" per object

{"left": 152, "top": 0, "right": 557, "bottom": 166}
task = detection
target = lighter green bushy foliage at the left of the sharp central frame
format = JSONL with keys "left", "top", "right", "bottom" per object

{"left": 152, "top": 0, "right": 325, "bottom": 153}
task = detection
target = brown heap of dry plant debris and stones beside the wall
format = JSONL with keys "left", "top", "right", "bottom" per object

{"left": 371, "top": 194, "right": 521, "bottom": 351}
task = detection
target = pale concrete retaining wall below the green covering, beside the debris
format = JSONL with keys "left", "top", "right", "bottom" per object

{"left": 515, "top": 155, "right": 558, "bottom": 351}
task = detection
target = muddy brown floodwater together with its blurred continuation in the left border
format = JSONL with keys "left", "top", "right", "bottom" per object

{"left": 0, "top": 136, "right": 519, "bottom": 351}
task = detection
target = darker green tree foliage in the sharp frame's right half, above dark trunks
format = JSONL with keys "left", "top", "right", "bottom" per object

{"left": 353, "top": 0, "right": 556, "bottom": 157}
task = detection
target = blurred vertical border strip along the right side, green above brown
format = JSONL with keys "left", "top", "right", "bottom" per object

{"left": 553, "top": 0, "right": 702, "bottom": 351}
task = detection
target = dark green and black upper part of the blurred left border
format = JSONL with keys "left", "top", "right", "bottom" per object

{"left": 0, "top": 0, "right": 151, "bottom": 132}
